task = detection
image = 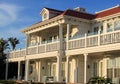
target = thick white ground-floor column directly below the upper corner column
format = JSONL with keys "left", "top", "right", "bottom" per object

{"left": 57, "top": 56, "right": 62, "bottom": 82}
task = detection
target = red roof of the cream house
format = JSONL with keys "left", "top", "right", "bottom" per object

{"left": 22, "top": 6, "right": 120, "bottom": 32}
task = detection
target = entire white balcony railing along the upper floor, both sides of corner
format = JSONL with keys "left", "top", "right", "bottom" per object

{"left": 9, "top": 30, "right": 120, "bottom": 58}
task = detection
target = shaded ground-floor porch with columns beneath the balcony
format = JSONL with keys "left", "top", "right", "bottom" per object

{"left": 8, "top": 51, "right": 120, "bottom": 84}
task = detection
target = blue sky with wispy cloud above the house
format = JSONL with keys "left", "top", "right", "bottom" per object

{"left": 0, "top": 0, "right": 120, "bottom": 48}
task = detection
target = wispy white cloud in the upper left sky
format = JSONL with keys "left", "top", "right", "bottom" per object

{"left": 0, "top": 3, "right": 21, "bottom": 27}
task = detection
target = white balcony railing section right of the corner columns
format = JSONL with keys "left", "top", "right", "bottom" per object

{"left": 68, "top": 31, "right": 120, "bottom": 50}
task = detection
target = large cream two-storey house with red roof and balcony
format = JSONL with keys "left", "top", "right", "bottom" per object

{"left": 8, "top": 5, "right": 120, "bottom": 84}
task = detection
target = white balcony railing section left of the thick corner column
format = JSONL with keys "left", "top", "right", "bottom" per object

{"left": 9, "top": 42, "right": 59, "bottom": 58}
